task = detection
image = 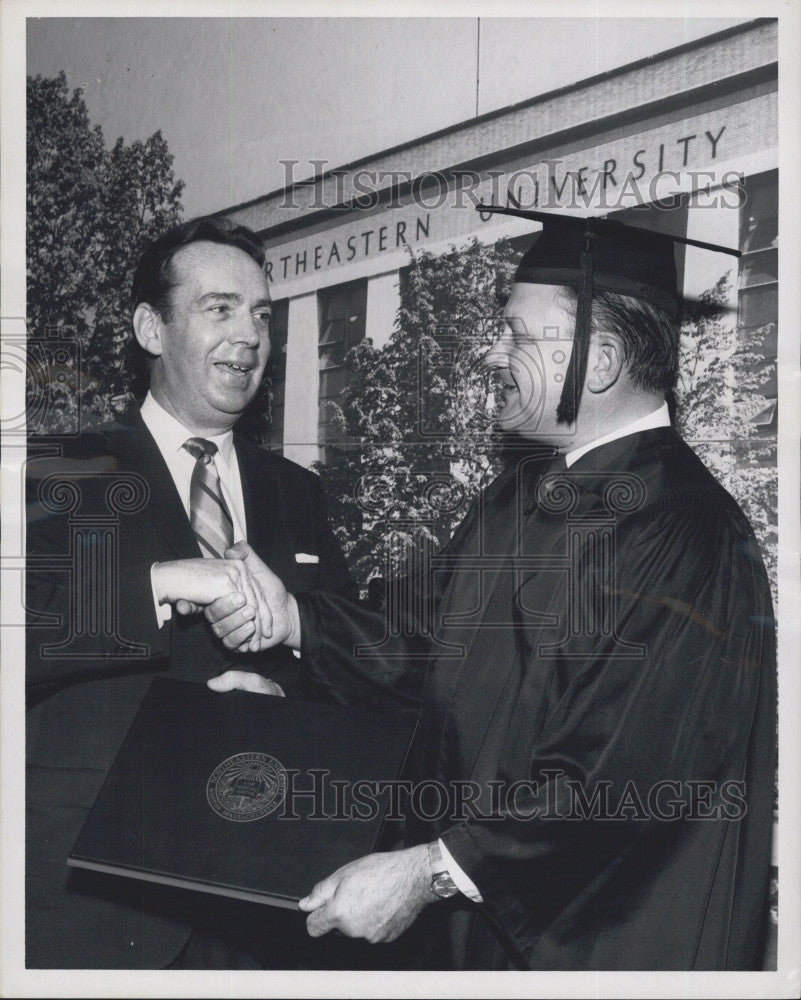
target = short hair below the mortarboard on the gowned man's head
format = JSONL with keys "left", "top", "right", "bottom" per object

{"left": 560, "top": 286, "right": 680, "bottom": 392}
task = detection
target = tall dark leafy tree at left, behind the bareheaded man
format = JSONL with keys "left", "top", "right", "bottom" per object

{"left": 27, "top": 72, "right": 183, "bottom": 432}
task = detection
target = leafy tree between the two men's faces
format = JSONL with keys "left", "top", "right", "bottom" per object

{"left": 318, "top": 240, "right": 517, "bottom": 583}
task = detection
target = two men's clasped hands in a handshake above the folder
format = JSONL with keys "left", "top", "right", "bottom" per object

{"left": 151, "top": 542, "right": 300, "bottom": 653}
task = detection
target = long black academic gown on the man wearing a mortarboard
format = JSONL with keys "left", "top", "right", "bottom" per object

{"left": 300, "top": 428, "right": 776, "bottom": 970}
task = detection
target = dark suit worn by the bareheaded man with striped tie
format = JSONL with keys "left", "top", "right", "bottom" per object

{"left": 26, "top": 411, "right": 356, "bottom": 969}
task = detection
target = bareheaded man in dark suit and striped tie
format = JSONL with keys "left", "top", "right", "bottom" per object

{"left": 26, "top": 219, "right": 354, "bottom": 968}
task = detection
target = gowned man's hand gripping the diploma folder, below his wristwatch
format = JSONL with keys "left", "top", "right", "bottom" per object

{"left": 299, "top": 844, "right": 436, "bottom": 944}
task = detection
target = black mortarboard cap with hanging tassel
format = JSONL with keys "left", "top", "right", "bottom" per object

{"left": 476, "top": 205, "right": 740, "bottom": 423}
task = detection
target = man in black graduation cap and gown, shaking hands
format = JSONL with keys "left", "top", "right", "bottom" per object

{"left": 200, "top": 209, "right": 776, "bottom": 970}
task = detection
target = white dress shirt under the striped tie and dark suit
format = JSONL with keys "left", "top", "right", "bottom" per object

{"left": 141, "top": 393, "right": 246, "bottom": 628}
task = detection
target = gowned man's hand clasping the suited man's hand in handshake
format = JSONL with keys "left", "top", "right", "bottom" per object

{"left": 205, "top": 542, "right": 300, "bottom": 652}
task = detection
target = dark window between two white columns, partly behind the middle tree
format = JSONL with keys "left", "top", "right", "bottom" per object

{"left": 318, "top": 281, "right": 367, "bottom": 461}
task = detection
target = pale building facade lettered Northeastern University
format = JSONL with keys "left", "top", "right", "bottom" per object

{"left": 219, "top": 20, "right": 778, "bottom": 466}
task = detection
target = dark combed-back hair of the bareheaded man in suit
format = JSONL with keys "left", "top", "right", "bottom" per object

{"left": 131, "top": 215, "right": 265, "bottom": 322}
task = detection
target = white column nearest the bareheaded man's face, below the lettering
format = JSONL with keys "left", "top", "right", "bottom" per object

{"left": 284, "top": 293, "right": 320, "bottom": 468}
